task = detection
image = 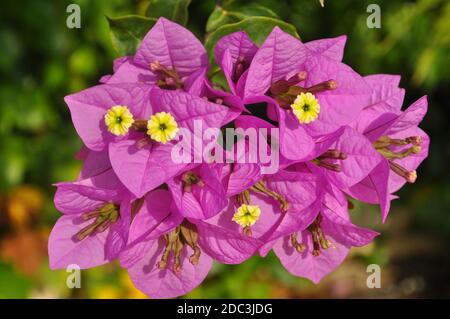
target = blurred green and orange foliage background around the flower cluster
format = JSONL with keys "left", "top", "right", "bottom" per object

{"left": 0, "top": 0, "right": 450, "bottom": 298}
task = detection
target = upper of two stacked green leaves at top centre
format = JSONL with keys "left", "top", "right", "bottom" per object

{"left": 206, "top": 4, "right": 278, "bottom": 33}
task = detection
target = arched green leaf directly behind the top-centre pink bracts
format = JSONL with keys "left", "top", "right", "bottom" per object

{"left": 205, "top": 17, "right": 299, "bottom": 64}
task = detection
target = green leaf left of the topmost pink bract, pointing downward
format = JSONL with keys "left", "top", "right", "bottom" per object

{"left": 106, "top": 15, "right": 156, "bottom": 55}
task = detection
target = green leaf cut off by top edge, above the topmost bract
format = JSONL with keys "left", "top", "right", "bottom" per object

{"left": 146, "top": 0, "right": 191, "bottom": 25}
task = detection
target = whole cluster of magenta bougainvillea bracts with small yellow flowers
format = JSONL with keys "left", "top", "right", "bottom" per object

{"left": 49, "top": 18, "right": 429, "bottom": 298}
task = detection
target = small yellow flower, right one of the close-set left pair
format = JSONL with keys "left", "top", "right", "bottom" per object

{"left": 147, "top": 112, "right": 178, "bottom": 144}
